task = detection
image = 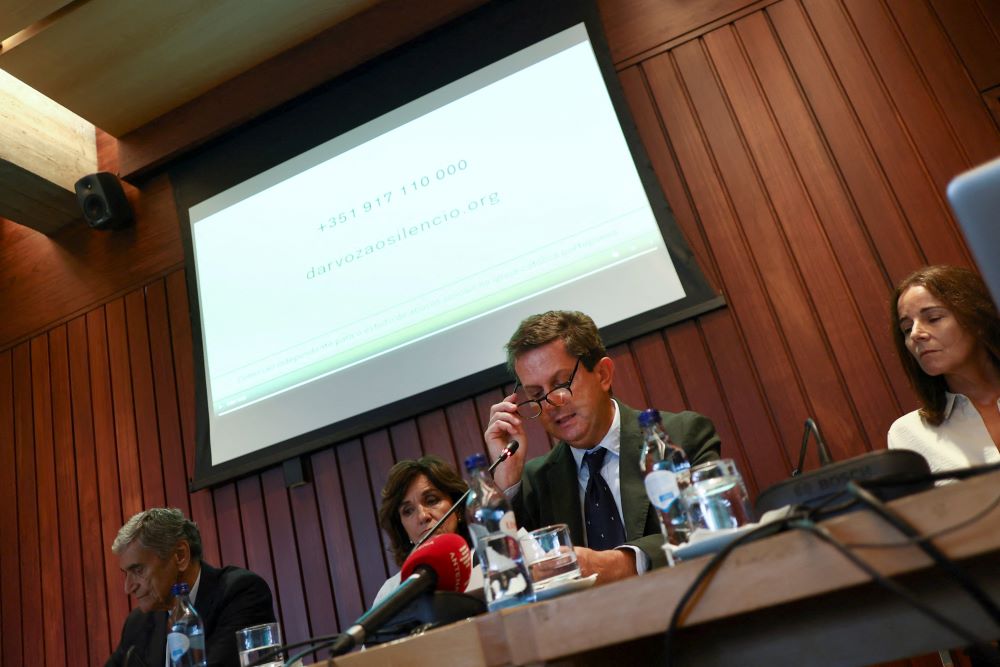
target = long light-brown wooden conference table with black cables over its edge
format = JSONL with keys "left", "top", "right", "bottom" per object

{"left": 329, "top": 472, "right": 1000, "bottom": 667}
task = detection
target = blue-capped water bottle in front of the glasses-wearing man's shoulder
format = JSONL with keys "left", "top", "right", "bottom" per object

{"left": 639, "top": 410, "right": 691, "bottom": 545}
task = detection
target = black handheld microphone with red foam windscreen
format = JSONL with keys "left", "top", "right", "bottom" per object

{"left": 331, "top": 533, "right": 472, "bottom": 655}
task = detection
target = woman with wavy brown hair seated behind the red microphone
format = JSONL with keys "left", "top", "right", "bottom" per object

{"left": 375, "top": 455, "right": 482, "bottom": 604}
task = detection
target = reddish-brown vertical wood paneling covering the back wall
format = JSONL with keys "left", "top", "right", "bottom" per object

{"left": 0, "top": 0, "right": 1000, "bottom": 665}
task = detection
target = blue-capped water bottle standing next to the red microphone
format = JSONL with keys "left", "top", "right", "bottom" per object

{"left": 465, "top": 454, "right": 535, "bottom": 611}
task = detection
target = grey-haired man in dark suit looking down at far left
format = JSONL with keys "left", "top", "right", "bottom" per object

{"left": 105, "top": 508, "right": 274, "bottom": 667}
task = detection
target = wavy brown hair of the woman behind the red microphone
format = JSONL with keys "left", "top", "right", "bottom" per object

{"left": 378, "top": 455, "right": 469, "bottom": 565}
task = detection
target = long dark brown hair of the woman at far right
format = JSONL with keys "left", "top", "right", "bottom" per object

{"left": 889, "top": 265, "right": 1000, "bottom": 426}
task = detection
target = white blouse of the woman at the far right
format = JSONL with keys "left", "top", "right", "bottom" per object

{"left": 888, "top": 392, "right": 1000, "bottom": 472}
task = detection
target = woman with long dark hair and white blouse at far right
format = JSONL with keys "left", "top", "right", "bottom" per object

{"left": 888, "top": 266, "right": 1000, "bottom": 472}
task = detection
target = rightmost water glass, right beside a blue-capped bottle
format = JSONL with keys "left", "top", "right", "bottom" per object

{"left": 681, "top": 459, "right": 755, "bottom": 530}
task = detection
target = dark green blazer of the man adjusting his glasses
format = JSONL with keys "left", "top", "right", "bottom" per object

{"left": 512, "top": 402, "right": 720, "bottom": 567}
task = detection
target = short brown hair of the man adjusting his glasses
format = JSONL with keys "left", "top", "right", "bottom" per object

{"left": 507, "top": 310, "right": 608, "bottom": 375}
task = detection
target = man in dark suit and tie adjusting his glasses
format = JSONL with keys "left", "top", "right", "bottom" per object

{"left": 484, "top": 311, "right": 719, "bottom": 583}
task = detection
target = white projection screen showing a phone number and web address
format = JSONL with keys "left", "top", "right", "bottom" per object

{"left": 189, "top": 24, "right": 684, "bottom": 465}
